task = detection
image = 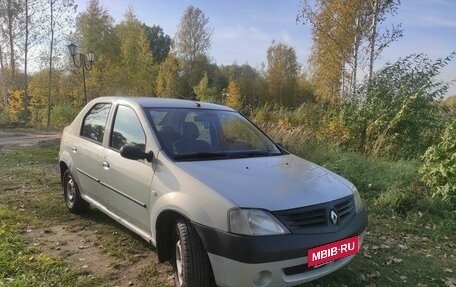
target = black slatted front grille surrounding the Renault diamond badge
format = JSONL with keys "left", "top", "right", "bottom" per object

{"left": 273, "top": 195, "right": 355, "bottom": 234}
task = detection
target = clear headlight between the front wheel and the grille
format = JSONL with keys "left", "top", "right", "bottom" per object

{"left": 228, "top": 209, "right": 289, "bottom": 235}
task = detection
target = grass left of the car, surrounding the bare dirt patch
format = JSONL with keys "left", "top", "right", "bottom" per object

{"left": 0, "top": 141, "right": 170, "bottom": 287}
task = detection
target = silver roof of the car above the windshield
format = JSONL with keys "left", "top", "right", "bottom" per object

{"left": 95, "top": 97, "right": 233, "bottom": 111}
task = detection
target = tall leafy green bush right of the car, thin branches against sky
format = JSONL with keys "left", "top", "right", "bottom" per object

{"left": 345, "top": 53, "right": 455, "bottom": 159}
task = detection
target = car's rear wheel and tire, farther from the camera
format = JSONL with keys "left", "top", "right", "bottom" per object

{"left": 62, "top": 169, "right": 90, "bottom": 214}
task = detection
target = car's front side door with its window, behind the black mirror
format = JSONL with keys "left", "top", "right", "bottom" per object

{"left": 101, "top": 104, "right": 153, "bottom": 233}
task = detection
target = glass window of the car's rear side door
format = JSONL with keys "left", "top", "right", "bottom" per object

{"left": 81, "top": 103, "right": 111, "bottom": 143}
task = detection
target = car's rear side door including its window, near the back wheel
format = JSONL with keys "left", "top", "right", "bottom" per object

{"left": 71, "top": 103, "right": 112, "bottom": 204}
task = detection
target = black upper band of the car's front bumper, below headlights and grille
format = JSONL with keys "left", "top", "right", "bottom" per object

{"left": 193, "top": 207, "right": 367, "bottom": 264}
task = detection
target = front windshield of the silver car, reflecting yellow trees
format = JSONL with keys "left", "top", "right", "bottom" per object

{"left": 145, "top": 108, "right": 282, "bottom": 161}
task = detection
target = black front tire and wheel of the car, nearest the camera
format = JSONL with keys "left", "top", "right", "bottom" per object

{"left": 173, "top": 219, "right": 215, "bottom": 287}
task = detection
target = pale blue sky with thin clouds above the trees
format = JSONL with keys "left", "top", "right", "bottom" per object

{"left": 75, "top": 0, "right": 456, "bottom": 96}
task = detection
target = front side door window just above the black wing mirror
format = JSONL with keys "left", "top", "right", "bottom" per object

{"left": 109, "top": 105, "right": 146, "bottom": 150}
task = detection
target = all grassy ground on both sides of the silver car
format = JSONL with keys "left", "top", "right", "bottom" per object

{"left": 0, "top": 137, "right": 456, "bottom": 287}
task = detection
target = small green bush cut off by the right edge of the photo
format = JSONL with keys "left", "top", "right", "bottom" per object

{"left": 420, "top": 120, "right": 456, "bottom": 205}
